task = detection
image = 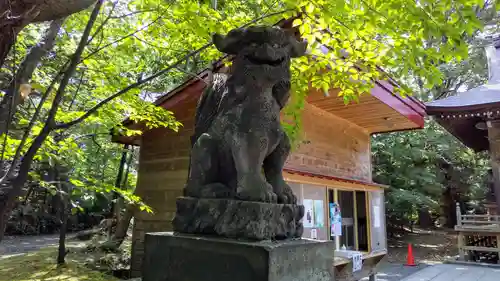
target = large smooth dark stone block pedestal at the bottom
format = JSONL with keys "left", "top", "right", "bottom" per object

{"left": 142, "top": 233, "right": 334, "bottom": 281}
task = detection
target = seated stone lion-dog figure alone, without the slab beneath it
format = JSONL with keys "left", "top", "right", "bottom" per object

{"left": 185, "top": 26, "right": 306, "bottom": 204}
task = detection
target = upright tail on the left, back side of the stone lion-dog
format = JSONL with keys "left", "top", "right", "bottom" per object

{"left": 191, "top": 73, "right": 228, "bottom": 146}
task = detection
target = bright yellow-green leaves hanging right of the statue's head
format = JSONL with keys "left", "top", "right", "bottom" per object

{"left": 285, "top": 0, "right": 491, "bottom": 140}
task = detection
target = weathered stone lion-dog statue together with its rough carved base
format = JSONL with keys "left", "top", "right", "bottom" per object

{"left": 176, "top": 26, "right": 306, "bottom": 240}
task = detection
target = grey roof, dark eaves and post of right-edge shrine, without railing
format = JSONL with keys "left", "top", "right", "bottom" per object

{"left": 426, "top": 38, "right": 500, "bottom": 214}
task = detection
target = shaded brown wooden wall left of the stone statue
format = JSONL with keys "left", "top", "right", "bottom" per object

{"left": 131, "top": 97, "right": 196, "bottom": 277}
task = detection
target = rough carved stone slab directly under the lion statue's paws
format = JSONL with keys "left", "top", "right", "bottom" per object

{"left": 173, "top": 197, "right": 304, "bottom": 240}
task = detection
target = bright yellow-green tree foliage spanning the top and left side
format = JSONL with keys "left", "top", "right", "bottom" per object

{"left": 0, "top": 0, "right": 496, "bottom": 220}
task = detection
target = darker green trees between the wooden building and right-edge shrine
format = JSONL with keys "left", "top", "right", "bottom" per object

{"left": 372, "top": 121, "right": 489, "bottom": 225}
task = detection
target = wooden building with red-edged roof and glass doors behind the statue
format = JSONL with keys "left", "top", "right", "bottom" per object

{"left": 114, "top": 20, "right": 425, "bottom": 280}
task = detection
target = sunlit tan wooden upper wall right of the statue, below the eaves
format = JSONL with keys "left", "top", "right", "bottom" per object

{"left": 286, "top": 103, "right": 372, "bottom": 181}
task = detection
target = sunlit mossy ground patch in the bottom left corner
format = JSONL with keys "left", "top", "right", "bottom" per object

{"left": 0, "top": 248, "right": 118, "bottom": 281}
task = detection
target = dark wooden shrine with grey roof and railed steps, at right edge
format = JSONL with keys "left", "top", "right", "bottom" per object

{"left": 426, "top": 38, "right": 500, "bottom": 263}
